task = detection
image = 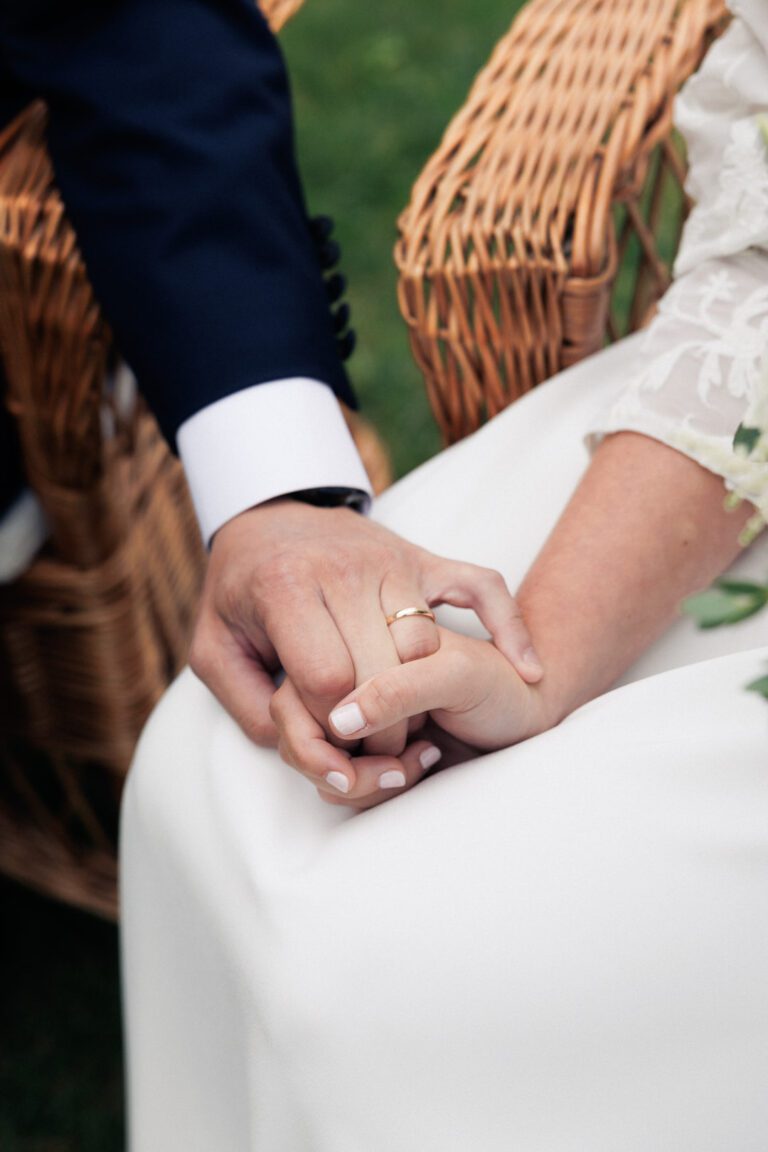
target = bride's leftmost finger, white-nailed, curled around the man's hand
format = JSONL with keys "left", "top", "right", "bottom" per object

{"left": 271, "top": 680, "right": 357, "bottom": 796}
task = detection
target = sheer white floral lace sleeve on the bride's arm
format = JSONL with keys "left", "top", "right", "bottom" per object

{"left": 590, "top": 0, "right": 768, "bottom": 520}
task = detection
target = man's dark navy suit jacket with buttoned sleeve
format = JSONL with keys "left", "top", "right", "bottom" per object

{"left": 0, "top": 0, "right": 352, "bottom": 509}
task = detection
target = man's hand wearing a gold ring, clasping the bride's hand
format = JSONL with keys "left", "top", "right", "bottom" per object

{"left": 190, "top": 499, "right": 541, "bottom": 755}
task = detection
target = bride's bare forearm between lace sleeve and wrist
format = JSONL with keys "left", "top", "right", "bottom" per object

{"left": 518, "top": 432, "right": 754, "bottom": 726}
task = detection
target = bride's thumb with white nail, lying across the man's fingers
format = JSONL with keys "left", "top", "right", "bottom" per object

{"left": 329, "top": 647, "right": 472, "bottom": 740}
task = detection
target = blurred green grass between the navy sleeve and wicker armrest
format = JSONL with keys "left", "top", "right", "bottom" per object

{"left": 282, "top": 0, "right": 529, "bottom": 475}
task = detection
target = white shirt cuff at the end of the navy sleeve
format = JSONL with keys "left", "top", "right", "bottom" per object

{"left": 176, "top": 377, "right": 372, "bottom": 545}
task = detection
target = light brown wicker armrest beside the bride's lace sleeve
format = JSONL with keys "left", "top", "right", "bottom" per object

{"left": 395, "top": 0, "right": 727, "bottom": 442}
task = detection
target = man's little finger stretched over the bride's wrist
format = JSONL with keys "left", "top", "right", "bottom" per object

{"left": 429, "top": 560, "right": 543, "bottom": 684}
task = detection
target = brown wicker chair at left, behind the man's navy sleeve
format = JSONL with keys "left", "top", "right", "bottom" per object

{"left": 0, "top": 0, "right": 389, "bottom": 917}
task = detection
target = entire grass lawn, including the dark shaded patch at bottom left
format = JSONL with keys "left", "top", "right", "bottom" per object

{"left": 0, "top": 0, "right": 529, "bottom": 1152}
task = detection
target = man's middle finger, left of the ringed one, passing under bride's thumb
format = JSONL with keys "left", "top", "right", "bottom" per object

{"left": 328, "top": 586, "right": 407, "bottom": 756}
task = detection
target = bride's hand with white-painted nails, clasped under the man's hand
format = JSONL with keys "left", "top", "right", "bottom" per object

{"left": 272, "top": 626, "right": 550, "bottom": 809}
